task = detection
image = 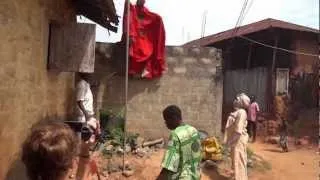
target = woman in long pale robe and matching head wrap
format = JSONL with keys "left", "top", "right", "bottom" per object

{"left": 224, "top": 93, "right": 250, "bottom": 180}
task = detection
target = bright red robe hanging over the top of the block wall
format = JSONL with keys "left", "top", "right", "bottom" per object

{"left": 122, "top": 1, "right": 166, "bottom": 79}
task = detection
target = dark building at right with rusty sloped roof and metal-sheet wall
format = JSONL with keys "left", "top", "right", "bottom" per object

{"left": 184, "top": 19, "right": 319, "bottom": 131}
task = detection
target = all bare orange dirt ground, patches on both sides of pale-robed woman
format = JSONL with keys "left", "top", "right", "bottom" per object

{"left": 104, "top": 142, "right": 320, "bottom": 180}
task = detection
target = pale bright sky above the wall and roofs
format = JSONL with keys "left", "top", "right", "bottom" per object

{"left": 78, "top": 0, "right": 319, "bottom": 45}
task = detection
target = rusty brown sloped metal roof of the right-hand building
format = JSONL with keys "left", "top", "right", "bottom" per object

{"left": 184, "top": 18, "right": 319, "bottom": 46}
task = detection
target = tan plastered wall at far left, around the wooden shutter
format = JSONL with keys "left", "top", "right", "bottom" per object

{"left": 0, "top": 0, "right": 76, "bottom": 179}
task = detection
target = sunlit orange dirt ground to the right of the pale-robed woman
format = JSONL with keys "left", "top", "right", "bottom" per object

{"left": 250, "top": 143, "right": 320, "bottom": 180}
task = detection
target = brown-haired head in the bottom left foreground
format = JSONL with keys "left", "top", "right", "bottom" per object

{"left": 22, "top": 122, "right": 79, "bottom": 180}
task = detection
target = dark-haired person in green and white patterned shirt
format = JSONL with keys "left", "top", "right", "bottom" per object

{"left": 158, "top": 105, "right": 201, "bottom": 180}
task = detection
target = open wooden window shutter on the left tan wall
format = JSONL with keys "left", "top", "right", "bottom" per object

{"left": 48, "top": 23, "right": 96, "bottom": 73}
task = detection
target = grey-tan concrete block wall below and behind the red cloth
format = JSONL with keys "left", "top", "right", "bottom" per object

{"left": 96, "top": 43, "right": 223, "bottom": 141}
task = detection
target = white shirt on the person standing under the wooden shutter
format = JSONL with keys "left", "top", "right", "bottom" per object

{"left": 76, "top": 80, "right": 94, "bottom": 122}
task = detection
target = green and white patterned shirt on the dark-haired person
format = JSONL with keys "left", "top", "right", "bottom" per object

{"left": 161, "top": 124, "right": 201, "bottom": 180}
